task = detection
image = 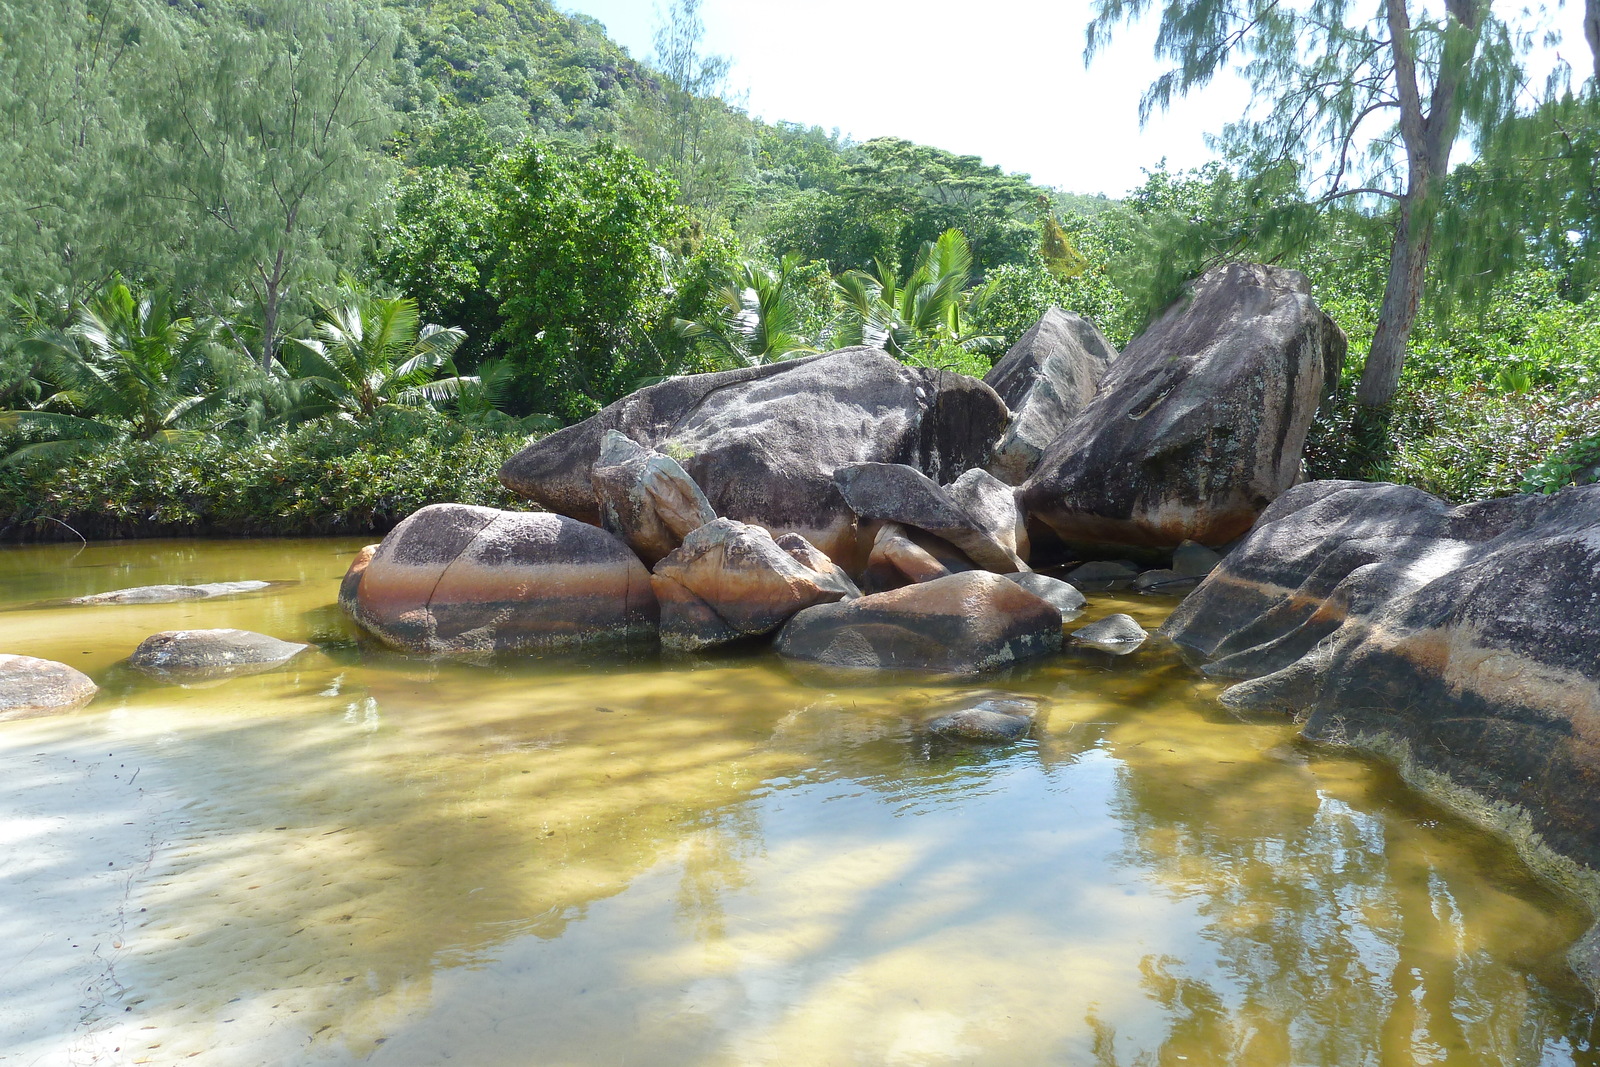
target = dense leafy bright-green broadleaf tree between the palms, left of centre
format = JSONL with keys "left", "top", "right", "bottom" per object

{"left": 494, "top": 142, "right": 682, "bottom": 419}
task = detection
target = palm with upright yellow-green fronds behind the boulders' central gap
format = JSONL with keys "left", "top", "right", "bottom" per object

{"left": 835, "top": 229, "right": 1000, "bottom": 360}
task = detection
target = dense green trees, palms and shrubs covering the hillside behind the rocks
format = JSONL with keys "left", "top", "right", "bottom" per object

{"left": 0, "top": 0, "right": 1600, "bottom": 536}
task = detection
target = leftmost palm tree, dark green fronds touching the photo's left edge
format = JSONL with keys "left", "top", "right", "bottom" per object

{"left": 0, "top": 278, "right": 240, "bottom": 462}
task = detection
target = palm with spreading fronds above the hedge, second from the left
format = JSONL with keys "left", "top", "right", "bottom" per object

{"left": 285, "top": 280, "right": 467, "bottom": 419}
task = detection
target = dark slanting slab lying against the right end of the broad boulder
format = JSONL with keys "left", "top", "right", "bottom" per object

{"left": 834, "top": 462, "right": 1027, "bottom": 574}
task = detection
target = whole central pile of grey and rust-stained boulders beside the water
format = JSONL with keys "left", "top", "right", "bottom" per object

{"left": 339, "top": 266, "right": 1344, "bottom": 672}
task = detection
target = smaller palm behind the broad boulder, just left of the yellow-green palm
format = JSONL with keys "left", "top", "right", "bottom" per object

{"left": 672, "top": 254, "right": 816, "bottom": 366}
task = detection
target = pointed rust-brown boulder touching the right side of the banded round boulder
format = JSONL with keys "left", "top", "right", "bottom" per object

{"left": 650, "top": 518, "right": 858, "bottom": 651}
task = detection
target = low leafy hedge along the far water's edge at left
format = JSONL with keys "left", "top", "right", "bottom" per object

{"left": 0, "top": 410, "right": 530, "bottom": 541}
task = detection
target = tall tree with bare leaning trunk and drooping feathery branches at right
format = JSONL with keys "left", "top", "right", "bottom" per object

{"left": 1085, "top": 0, "right": 1523, "bottom": 406}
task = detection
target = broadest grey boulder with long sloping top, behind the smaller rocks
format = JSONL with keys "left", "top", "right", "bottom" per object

{"left": 501, "top": 349, "right": 1010, "bottom": 573}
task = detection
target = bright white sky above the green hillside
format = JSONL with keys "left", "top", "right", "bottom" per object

{"left": 557, "top": 0, "right": 1589, "bottom": 197}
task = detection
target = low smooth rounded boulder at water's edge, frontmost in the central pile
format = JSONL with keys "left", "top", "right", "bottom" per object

{"left": 778, "top": 571, "right": 1061, "bottom": 673}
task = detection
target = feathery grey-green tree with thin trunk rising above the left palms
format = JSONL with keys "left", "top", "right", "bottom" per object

{"left": 149, "top": 0, "right": 394, "bottom": 368}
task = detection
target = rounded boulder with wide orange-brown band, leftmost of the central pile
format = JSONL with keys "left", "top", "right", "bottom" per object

{"left": 339, "top": 504, "right": 658, "bottom": 653}
